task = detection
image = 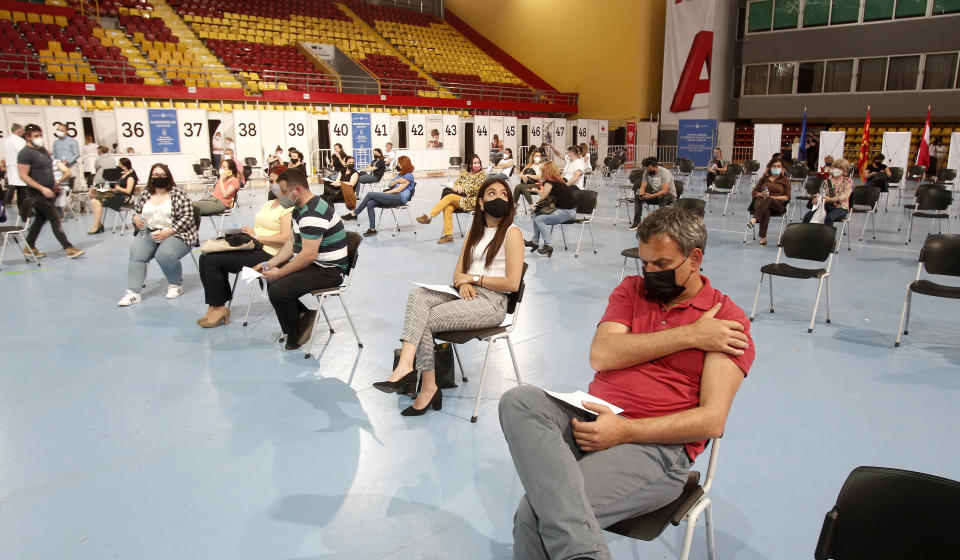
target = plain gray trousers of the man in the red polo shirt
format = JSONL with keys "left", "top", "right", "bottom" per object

{"left": 500, "top": 385, "right": 691, "bottom": 560}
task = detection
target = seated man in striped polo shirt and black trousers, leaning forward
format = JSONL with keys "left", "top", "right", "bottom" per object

{"left": 254, "top": 169, "right": 347, "bottom": 350}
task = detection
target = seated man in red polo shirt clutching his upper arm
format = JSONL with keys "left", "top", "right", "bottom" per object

{"left": 500, "top": 207, "right": 754, "bottom": 560}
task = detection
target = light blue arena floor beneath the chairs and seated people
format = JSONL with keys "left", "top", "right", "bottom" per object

{"left": 0, "top": 173, "right": 960, "bottom": 560}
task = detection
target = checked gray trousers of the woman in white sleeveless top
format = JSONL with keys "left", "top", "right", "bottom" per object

{"left": 400, "top": 287, "right": 507, "bottom": 372}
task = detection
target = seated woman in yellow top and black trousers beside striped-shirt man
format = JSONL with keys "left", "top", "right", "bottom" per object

{"left": 197, "top": 165, "right": 293, "bottom": 329}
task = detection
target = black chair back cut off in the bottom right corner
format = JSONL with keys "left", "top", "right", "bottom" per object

{"left": 813, "top": 467, "right": 960, "bottom": 560}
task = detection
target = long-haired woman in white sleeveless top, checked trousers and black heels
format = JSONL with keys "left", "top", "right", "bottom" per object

{"left": 373, "top": 179, "right": 523, "bottom": 416}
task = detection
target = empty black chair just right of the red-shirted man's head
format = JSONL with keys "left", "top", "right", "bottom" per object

{"left": 750, "top": 223, "right": 837, "bottom": 333}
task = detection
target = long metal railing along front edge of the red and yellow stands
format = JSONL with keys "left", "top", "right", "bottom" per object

{"left": 0, "top": 53, "right": 578, "bottom": 105}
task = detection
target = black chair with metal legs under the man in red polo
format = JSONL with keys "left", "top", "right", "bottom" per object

{"left": 606, "top": 438, "right": 720, "bottom": 560}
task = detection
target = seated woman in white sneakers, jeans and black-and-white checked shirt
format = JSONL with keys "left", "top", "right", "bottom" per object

{"left": 117, "top": 163, "right": 198, "bottom": 307}
